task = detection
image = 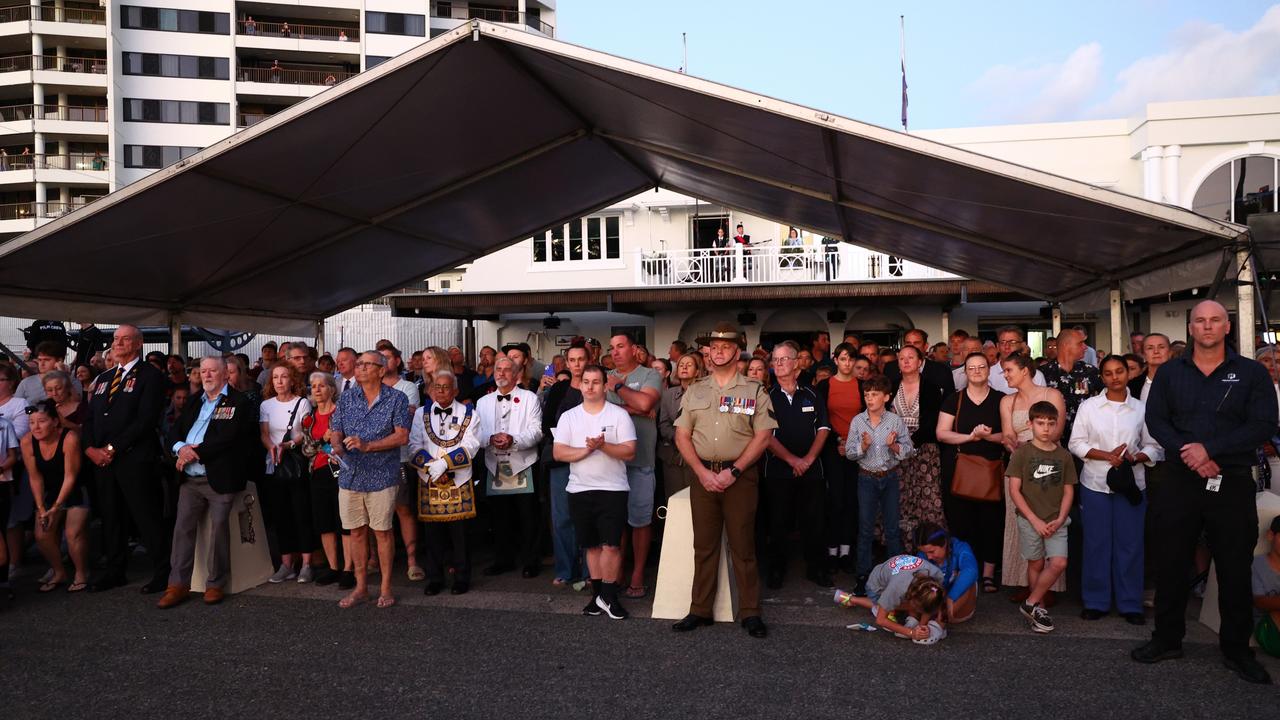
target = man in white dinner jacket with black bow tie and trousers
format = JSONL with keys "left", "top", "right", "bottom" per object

{"left": 476, "top": 355, "right": 543, "bottom": 578}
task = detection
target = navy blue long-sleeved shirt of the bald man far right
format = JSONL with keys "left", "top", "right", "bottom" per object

{"left": 1147, "top": 348, "right": 1277, "bottom": 469}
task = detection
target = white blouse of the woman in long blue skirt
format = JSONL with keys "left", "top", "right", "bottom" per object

{"left": 1066, "top": 391, "right": 1165, "bottom": 493}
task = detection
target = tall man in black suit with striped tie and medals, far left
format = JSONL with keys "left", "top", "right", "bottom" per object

{"left": 81, "top": 325, "right": 170, "bottom": 594}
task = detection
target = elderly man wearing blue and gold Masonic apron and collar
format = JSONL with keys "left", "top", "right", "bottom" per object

{"left": 408, "top": 370, "right": 480, "bottom": 596}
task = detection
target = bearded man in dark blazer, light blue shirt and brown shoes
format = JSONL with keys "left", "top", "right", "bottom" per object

{"left": 156, "top": 356, "right": 262, "bottom": 610}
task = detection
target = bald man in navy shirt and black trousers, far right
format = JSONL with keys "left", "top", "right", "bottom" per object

{"left": 1132, "top": 300, "right": 1277, "bottom": 684}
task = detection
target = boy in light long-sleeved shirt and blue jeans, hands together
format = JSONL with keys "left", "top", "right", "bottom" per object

{"left": 845, "top": 375, "right": 913, "bottom": 594}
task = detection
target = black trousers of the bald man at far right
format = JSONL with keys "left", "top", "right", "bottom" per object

{"left": 1148, "top": 459, "right": 1258, "bottom": 657}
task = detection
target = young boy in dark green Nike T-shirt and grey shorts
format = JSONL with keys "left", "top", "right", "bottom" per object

{"left": 1005, "top": 401, "right": 1076, "bottom": 633}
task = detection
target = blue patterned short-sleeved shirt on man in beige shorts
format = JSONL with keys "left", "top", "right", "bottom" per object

{"left": 329, "top": 384, "right": 410, "bottom": 492}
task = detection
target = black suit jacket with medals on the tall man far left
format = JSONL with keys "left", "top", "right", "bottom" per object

{"left": 81, "top": 357, "right": 169, "bottom": 461}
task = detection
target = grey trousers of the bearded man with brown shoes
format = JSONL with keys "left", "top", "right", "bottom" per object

{"left": 169, "top": 475, "right": 236, "bottom": 588}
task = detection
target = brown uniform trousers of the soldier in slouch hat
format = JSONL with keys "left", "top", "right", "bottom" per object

{"left": 686, "top": 465, "right": 760, "bottom": 619}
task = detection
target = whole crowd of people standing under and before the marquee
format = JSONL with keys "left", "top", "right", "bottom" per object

{"left": 0, "top": 301, "right": 1280, "bottom": 682}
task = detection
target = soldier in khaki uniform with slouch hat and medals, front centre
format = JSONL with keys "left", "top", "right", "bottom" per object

{"left": 672, "top": 323, "right": 778, "bottom": 638}
